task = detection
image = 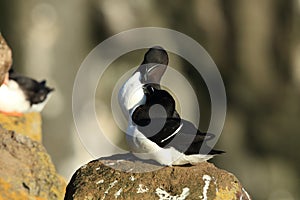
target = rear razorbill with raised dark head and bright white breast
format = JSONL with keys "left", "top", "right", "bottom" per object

{"left": 118, "top": 46, "right": 179, "bottom": 118}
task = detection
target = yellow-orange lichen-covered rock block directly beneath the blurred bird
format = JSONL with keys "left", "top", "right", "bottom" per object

{"left": 0, "top": 112, "right": 42, "bottom": 142}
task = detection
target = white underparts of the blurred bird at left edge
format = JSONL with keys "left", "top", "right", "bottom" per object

{"left": 0, "top": 80, "right": 30, "bottom": 113}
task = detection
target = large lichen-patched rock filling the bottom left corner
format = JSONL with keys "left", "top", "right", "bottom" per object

{"left": 0, "top": 127, "right": 66, "bottom": 200}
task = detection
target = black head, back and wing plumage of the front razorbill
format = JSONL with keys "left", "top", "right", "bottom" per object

{"left": 132, "top": 84, "right": 223, "bottom": 155}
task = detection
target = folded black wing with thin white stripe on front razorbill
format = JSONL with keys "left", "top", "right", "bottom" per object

{"left": 138, "top": 118, "right": 222, "bottom": 155}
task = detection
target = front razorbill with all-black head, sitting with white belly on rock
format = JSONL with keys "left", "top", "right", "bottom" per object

{"left": 127, "top": 84, "right": 223, "bottom": 166}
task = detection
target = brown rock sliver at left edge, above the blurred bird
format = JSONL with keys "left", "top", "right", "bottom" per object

{"left": 0, "top": 33, "right": 12, "bottom": 85}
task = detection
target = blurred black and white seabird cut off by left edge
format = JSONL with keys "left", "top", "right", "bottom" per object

{"left": 0, "top": 70, "right": 53, "bottom": 115}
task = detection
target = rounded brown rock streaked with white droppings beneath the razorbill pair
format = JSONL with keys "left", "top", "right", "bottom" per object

{"left": 65, "top": 154, "right": 250, "bottom": 200}
